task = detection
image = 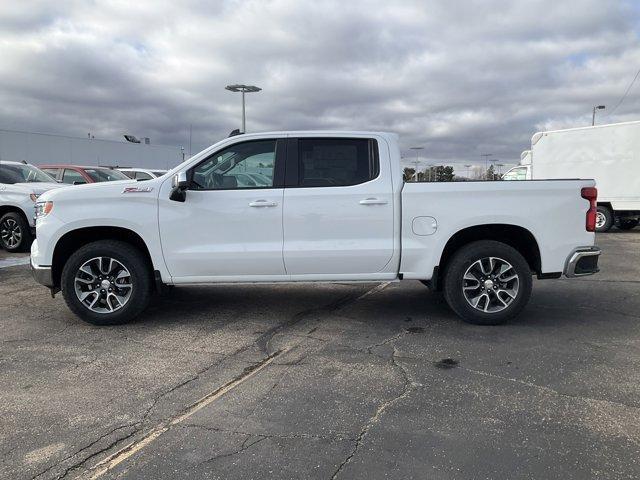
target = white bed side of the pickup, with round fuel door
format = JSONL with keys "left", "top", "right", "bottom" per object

{"left": 400, "top": 180, "right": 595, "bottom": 279}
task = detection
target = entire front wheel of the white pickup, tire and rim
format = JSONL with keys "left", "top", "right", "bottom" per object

{"left": 61, "top": 240, "right": 152, "bottom": 325}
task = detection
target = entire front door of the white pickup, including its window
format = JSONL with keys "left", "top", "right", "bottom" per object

{"left": 159, "top": 139, "right": 285, "bottom": 281}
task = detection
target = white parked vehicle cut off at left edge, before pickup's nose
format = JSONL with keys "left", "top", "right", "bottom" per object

{"left": 0, "top": 160, "right": 60, "bottom": 252}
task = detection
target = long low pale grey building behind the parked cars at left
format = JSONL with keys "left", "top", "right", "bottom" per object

{"left": 0, "top": 129, "right": 184, "bottom": 170}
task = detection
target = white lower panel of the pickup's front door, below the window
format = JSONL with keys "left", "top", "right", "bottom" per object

{"left": 160, "top": 188, "right": 285, "bottom": 277}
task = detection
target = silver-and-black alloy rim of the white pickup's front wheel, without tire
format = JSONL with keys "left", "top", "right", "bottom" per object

{"left": 73, "top": 257, "right": 133, "bottom": 313}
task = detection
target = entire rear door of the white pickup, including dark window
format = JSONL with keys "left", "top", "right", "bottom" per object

{"left": 283, "top": 139, "right": 394, "bottom": 275}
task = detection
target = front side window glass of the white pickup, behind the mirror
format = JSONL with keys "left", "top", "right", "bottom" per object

{"left": 191, "top": 140, "right": 276, "bottom": 190}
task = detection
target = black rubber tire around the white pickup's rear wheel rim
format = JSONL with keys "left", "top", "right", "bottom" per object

{"left": 443, "top": 240, "right": 533, "bottom": 325}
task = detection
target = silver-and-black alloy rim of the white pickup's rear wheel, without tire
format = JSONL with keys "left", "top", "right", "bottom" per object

{"left": 462, "top": 257, "right": 520, "bottom": 313}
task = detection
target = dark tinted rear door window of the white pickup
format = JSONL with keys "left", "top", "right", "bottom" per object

{"left": 298, "top": 138, "right": 379, "bottom": 187}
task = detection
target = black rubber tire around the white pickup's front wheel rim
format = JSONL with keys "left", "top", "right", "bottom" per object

{"left": 60, "top": 240, "right": 153, "bottom": 325}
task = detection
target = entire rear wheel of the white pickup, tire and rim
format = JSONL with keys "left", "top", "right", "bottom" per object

{"left": 443, "top": 240, "right": 533, "bottom": 325}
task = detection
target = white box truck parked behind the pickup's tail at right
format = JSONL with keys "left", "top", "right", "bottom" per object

{"left": 505, "top": 122, "right": 640, "bottom": 231}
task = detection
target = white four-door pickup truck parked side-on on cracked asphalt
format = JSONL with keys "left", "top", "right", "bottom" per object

{"left": 31, "top": 132, "right": 600, "bottom": 325}
